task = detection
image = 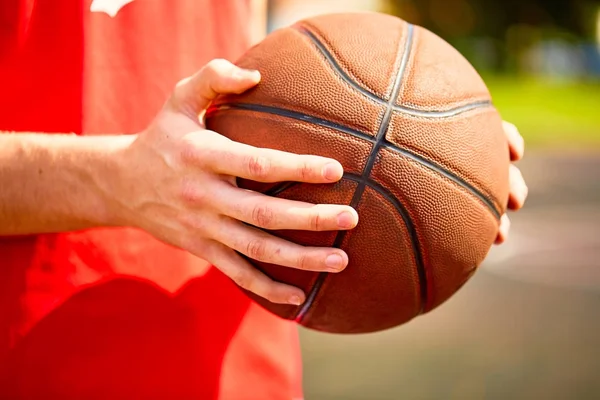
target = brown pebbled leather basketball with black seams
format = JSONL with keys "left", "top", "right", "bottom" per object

{"left": 206, "top": 13, "right": 509, "bottom": 333}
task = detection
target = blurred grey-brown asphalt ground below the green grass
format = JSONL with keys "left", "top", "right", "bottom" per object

{"left": 301, "top": 152, "right": 600, "bottom": 400}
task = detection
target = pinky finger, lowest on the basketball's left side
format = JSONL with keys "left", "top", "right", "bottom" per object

{"left": 202, "top": 242, "right": 305, "bottom": 305}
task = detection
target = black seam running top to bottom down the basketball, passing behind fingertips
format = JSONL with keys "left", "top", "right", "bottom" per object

{"left": 295, "top": 21, "right": 423, "bottom": 322}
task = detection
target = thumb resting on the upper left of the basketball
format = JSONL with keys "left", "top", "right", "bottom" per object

{"left": 170, "top": 59, "right": 260, "bottom": 115}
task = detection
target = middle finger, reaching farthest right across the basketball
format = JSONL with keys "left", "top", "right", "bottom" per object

{"left": 213, "top": 183, "right": 358, "bottom": 231}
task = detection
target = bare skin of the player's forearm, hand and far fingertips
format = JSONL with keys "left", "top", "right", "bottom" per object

{"left": 0, "top": 49, "right": 527, "bottom": 310}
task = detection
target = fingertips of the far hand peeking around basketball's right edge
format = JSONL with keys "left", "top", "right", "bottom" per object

{"left": 496, "top": 121, "right": 529, "bottom": 244}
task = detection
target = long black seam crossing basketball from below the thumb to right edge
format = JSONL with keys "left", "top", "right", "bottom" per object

{"left": 210, "top": 103, "right": 500, "bottom": 219}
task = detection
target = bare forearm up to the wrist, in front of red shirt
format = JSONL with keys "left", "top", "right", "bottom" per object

{"left": 0, "top": 133, "right": 134, "bottom": 236}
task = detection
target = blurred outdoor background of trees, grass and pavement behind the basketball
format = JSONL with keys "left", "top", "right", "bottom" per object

{"left": 269, "top": 0, "right": 600, "bottom": 400}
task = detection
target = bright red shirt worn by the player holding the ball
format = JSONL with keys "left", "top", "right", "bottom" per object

{"left": 0, "top": 0, "right": 301, "bottom": 400}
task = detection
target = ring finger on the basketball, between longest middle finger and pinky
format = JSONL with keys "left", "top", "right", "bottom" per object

{"left": 213, "top": 217, "right": 348, "bottom": 272}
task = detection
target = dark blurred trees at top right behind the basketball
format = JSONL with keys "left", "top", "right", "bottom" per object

{"left": 384, "top": 0, "right": 600, "bottom": 71}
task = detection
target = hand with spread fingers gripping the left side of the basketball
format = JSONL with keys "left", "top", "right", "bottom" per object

{"left": 112, "top": 60, "right": 358, "bottom": 304}
